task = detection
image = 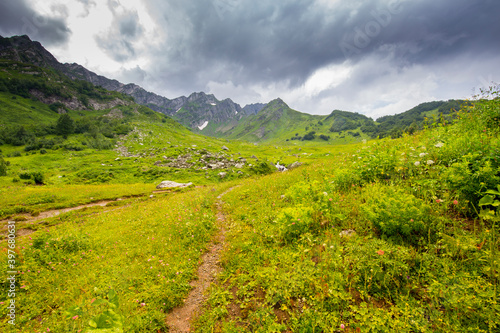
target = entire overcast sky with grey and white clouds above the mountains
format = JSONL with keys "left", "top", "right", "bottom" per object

{"left": 0, "top": 0, "right": 500, "bottom": 119}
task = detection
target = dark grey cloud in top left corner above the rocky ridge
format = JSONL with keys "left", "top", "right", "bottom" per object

{"left": 0, "top": 0, "right": 71, "bottom": 46}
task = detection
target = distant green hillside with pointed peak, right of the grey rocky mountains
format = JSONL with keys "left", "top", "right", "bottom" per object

{"left": 206, "top": 99, "right": 464, "bottom": 145}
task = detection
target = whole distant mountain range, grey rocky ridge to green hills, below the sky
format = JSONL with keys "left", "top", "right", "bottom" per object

{"left": 0, "top": 36, "right": 461, "bottom": 142}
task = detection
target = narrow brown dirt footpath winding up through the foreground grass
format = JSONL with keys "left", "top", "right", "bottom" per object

{"left": 167, "top": 188, "right": 233, "bottom": 333}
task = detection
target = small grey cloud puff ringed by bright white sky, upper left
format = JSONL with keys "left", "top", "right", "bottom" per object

{"left": 95, "top": 0, "right": 144, "bottom": 62}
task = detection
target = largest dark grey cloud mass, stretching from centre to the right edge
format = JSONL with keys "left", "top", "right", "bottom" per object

{"left": 146, "top": 0, "right": 500, "bottom": 93}
